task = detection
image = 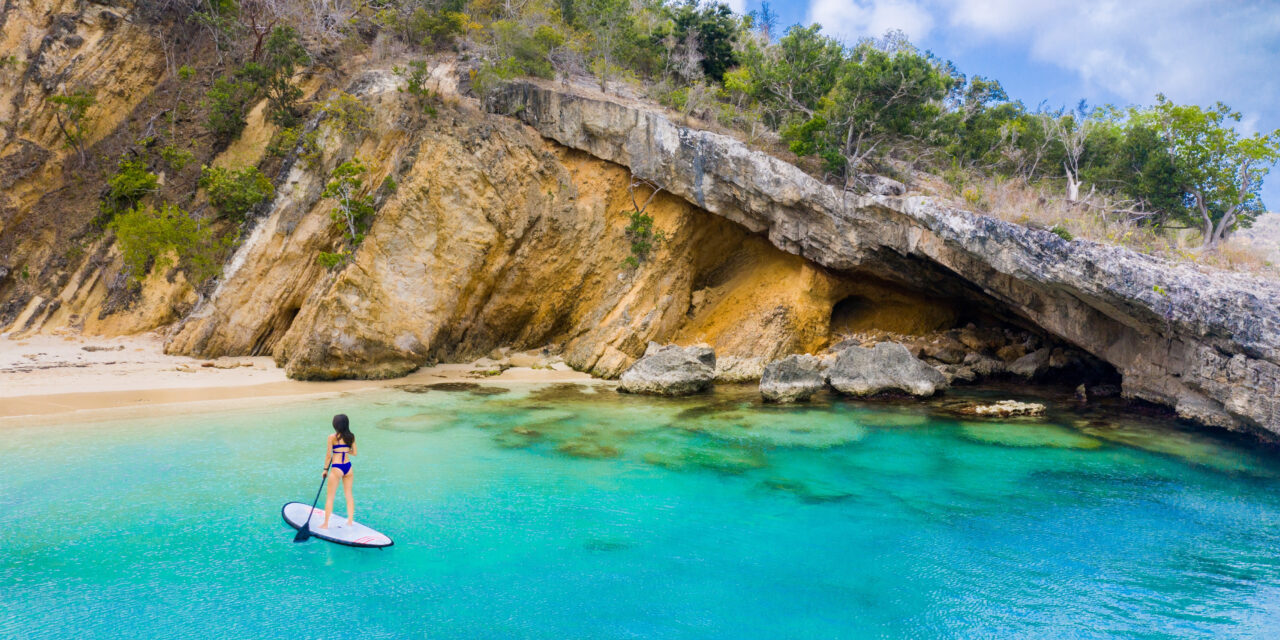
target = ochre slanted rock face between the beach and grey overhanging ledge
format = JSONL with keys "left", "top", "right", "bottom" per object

{"left": 168, "top": 72, "right": 850, "bottom": 379}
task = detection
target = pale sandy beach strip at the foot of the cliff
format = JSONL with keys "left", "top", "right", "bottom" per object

{"left": 0, "top": 334, "right": 594, "bottom": 417}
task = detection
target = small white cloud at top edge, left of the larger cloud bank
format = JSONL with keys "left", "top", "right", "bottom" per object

{"left": 808, "top": 0, "right": 933, "bottom": 42}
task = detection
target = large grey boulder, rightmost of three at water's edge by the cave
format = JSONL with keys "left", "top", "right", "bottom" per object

{"left": 827, "top": 342, "right": 947, "bottom": 397}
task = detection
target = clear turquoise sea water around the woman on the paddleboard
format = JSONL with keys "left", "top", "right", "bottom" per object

{"left": 0, "top": 387, "right": 1280, "bottom": 639}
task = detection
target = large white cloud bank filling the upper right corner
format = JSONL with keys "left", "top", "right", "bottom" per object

{"left": 933, "top": 0, "right": 1280, "bottom": 106}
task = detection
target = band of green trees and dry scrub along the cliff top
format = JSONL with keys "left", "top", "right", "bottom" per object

{"left": 47, "top": 0, "right": 1280, "bottom": 276}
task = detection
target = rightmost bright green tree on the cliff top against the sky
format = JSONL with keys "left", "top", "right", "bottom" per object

{"left": 1138, "top": 95, "right": 1280, "bottom": 250}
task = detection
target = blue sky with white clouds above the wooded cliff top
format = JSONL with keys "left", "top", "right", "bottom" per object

{"left": 728, "top": 0, "right": 1280, "bottom": 211}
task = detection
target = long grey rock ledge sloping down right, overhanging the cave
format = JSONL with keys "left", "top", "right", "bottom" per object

{"left": 492, "top": 82, "right": 1280, "bottom": 438}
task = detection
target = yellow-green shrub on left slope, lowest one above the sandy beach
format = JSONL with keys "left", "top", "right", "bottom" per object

{"left": 110, "top": 204, "right": 228, "bottom": 283}
